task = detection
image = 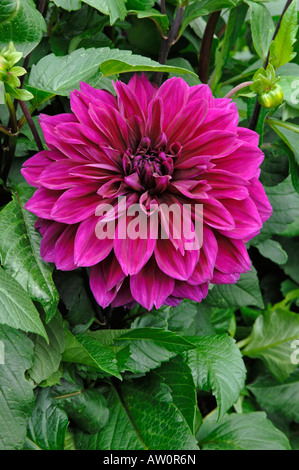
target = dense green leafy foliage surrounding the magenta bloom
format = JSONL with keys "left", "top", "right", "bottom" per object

{"left": 0, "top": 0, "right": 299, "bottom": 450}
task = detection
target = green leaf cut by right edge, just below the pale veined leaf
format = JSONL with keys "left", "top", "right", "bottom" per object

{"left": 247, "top": 369, "right": 299, "bottom": 423}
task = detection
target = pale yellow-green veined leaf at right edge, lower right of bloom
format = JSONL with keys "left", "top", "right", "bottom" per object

{"left": 242, "top": 308, "right": 299, "bottom": 381}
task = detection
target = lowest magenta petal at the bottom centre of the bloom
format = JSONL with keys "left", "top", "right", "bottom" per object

{"left": 130, "top": 257, "right": 174, "bottom": 310}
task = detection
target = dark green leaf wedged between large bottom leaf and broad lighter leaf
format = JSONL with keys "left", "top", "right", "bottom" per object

{"left": 154, "top": 356, "right": 197, "bottom": 434}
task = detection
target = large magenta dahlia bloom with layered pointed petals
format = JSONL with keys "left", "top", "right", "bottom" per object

{"left": 22, "top": 74, "right": 271, "bottom": 310}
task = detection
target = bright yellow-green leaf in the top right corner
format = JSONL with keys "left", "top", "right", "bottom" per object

{"left": 269, "top": 0, "right": 298, "bottom": 69}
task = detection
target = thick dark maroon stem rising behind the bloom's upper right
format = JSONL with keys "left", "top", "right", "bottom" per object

{"left": 198, "top": 10, "right": 221, "bottom": 83}
